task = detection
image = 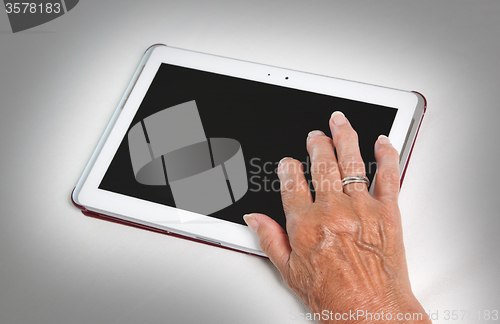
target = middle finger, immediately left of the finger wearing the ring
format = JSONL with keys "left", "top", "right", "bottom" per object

{"left": 307, "top": 130, "right": 342, "bottom": 199}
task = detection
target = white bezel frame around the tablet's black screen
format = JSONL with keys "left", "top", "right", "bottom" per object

{"left": 73, "top": 45, "right": 423, "bottom": 255}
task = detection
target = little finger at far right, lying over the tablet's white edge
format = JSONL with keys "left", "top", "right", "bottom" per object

{"left": 373, "top": 135, "right": 400, "bottom": 202}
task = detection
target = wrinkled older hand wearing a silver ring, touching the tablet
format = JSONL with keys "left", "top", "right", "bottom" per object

{"left": 244, "top": 112, "right": 430, "bottom": 323}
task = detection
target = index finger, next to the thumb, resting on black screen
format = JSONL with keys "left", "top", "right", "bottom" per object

{"left": 278, "top": 158, "right": 312, "bottom": 219}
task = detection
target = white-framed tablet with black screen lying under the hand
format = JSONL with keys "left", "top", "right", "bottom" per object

{"left": 72, "top": 45, "right": 425, "bottom": 255}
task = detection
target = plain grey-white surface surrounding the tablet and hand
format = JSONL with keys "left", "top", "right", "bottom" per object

{"left": 0, "top": 0, "right": 500, "bottom": 324}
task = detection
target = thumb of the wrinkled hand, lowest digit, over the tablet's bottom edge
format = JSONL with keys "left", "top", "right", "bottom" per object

{"left": 243, "top": 213, "right": 292, "bottom": 275}
